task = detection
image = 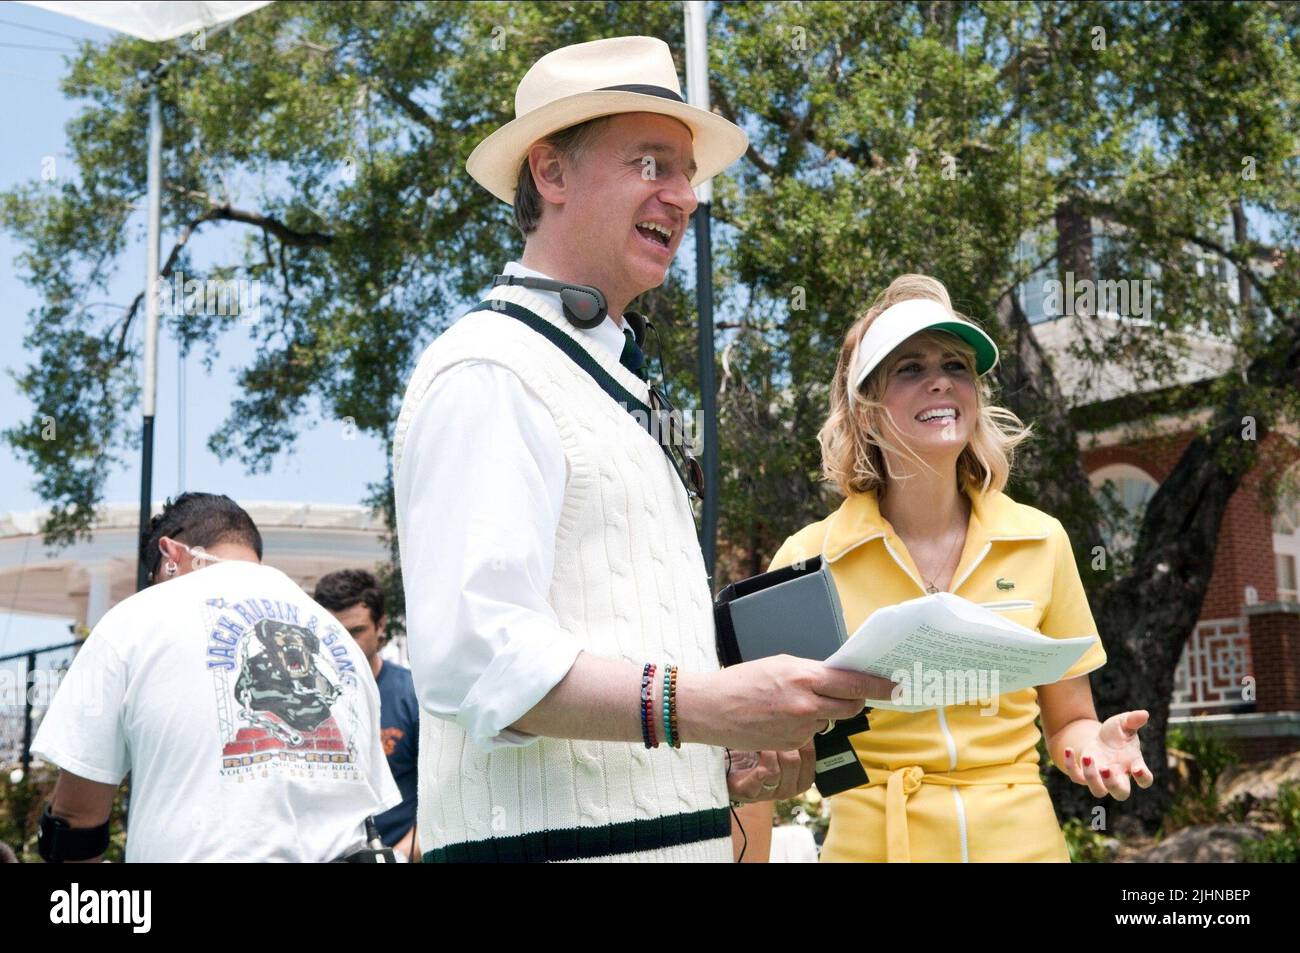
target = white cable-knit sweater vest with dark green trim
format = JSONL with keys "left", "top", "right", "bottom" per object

{"left": 393, "top": 287, "right": 732, "bottom": 862}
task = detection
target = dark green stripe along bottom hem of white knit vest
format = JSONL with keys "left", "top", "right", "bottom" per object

{"left": 424, "top": 807, "right": 731, "bottom": 863}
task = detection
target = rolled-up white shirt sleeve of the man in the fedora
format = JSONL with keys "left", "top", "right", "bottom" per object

{"left": 394, "top": 361, "right": 579, "bottom": 749}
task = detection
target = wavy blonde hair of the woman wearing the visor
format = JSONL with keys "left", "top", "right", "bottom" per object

{"left": 818, "top": 274, "right": 1031, "bottom": 497}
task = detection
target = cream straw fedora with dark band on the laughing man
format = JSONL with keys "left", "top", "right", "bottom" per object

{"left": 465, "top": 36, "right": 749, "bottom": 205}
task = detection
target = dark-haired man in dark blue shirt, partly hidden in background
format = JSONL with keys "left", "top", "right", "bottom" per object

{"left": 312, "top": 569, "right": 420, "bottom": 859}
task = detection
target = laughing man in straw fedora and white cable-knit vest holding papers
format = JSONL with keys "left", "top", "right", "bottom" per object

{"left": 393, "top": 36, "right": 888, "bottom": 861}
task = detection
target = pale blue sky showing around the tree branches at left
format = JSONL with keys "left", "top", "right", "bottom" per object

{"left": 0, "top": 3, "right": 384, "bottom": 655}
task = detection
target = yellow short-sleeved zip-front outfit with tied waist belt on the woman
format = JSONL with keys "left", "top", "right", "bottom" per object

{"left": 772, "top": 490, "right": 1106, "bottom": 862}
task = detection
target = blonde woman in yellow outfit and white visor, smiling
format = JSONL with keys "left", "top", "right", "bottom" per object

{"left": 772, "top": 274, "right": 1153, "bottom": 862}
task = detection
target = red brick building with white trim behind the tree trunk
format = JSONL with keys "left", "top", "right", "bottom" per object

{"left": 1035, "top": 316, "right": 1300, "bottom": 761}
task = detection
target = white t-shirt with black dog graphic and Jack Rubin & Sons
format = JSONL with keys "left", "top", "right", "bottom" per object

{"left": 33, "top": 562, "right": 402, "bottom": 861}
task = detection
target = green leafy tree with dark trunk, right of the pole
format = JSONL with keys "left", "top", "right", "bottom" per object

{"left": 714, "top": 3, "right": 1300, "bottom": 829}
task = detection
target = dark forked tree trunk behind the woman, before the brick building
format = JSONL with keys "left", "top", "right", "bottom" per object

{"left": 998, "top": 259, "right": 1297, "bottom": 832}
